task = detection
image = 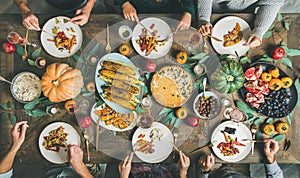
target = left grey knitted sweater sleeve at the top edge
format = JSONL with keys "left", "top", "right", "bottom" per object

{"left": 197, "top": 0, "right": 213, "bottom": 25}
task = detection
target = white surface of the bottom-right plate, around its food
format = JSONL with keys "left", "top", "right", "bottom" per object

{"left": 211, "top": 121, "right": 252, "bottom": 162}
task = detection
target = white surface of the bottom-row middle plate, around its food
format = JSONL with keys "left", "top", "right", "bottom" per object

{"left": 132, "top": 122, "right": 174, "bottom": 163}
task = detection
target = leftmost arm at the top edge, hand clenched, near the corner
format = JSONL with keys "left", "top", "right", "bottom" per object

{"left": 15, "top": 0, "right": 41, "bottom": 31}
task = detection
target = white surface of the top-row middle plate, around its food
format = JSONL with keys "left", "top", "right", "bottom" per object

{"left": 132, "top": 17, "right": 173, "bottom": 59}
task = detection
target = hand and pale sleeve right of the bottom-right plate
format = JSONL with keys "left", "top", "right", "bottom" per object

{"left": 264, "top": 139, "right": 283, "bottom": 178}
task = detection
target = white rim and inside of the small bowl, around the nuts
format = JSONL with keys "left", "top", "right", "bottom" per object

{"left": 193, "top": 91, "right": 222, "bottom": 119}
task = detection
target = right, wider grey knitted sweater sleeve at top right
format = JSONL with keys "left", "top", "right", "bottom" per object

{"left": 252, "top": 0, "right": 284, "bottom": 38}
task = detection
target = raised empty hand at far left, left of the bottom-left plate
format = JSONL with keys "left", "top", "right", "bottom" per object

{"left": 11, "top": 121, "right": 29, "bottom": 150}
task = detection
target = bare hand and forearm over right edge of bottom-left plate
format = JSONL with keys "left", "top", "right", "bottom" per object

{"left": 68, "top": 145, "right": 94, "bottom": 178}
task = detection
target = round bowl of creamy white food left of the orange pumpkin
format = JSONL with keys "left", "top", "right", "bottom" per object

{"left": 10, "top": 72, "right": 42, "bottom": 103}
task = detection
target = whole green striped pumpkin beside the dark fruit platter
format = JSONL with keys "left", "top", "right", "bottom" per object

{"left": 210, "top": 60, "right": 245, "bottom": 94}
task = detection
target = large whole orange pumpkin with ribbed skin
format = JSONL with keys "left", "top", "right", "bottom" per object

{"left": 40, "top": 63, "right": 84, "bottom": 102}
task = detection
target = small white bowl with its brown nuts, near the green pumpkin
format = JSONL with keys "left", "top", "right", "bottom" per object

{"left": 193, "top": 91, "right": 222, "bottom": 119}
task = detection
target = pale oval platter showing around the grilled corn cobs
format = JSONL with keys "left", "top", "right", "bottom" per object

{"left": 95, "top": 53, "right": 142, "bottom": 114}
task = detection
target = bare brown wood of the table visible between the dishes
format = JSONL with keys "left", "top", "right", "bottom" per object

{"left": 0, "top": 14, "right": 300, "bottom": 168}
